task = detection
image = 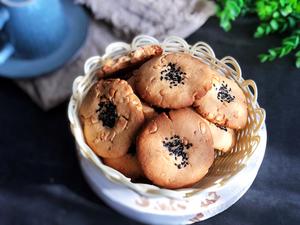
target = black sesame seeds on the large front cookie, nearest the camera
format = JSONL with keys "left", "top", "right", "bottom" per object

{"left": 162, "top": 135, "right": 193, "bottom": 169}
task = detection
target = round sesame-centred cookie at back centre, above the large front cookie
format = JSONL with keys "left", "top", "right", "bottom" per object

{"left": 135, "top": 53, "right": 213, "bottom": 109}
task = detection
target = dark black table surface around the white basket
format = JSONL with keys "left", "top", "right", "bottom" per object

{"left": 0, "top": 18, "right": 300, "bottom": 225}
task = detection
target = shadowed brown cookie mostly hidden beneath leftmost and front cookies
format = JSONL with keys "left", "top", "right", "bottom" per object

{"left": 103, "top": 147, "right": 143, "bottom": 179}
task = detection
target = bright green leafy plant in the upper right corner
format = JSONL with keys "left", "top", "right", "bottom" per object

{"left": 217, "top": 0, "right": 300, "bottom": 68}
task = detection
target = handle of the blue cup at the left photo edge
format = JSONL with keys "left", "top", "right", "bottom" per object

{"left": 0, "top": 7, "right": 15, "bottom": 64}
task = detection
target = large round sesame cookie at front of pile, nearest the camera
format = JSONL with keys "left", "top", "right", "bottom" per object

{"left": 137, "top": 108, "right": 214, "bottom": 189}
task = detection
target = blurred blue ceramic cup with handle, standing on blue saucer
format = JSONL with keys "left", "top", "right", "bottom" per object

{"left": 0, "top": 0, "right": 67, "bottom": 64}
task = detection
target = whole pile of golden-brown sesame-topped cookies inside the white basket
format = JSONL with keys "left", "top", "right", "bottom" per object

{"left": 80, "top": 45, "right": 248, "bottom": 189}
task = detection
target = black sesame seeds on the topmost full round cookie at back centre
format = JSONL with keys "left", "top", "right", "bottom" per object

{"left": 160, "top": 63, "right": 186, "bottom": 88}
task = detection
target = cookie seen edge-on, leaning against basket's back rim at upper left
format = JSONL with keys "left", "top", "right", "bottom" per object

{"left": 96, "top": 45, "right": 163, "bottom": 78}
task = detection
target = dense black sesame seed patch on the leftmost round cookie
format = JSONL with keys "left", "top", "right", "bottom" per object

{"left": 96, "top": 100, "right": 118, "bottom": 128}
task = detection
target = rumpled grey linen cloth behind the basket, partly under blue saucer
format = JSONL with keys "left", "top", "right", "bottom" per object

{"left": 16, "top": 0, "right": 215, "bottom": 110}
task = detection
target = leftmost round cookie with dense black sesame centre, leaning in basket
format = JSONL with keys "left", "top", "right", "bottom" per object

{"left": 80, "top": 79, "right": 144, "bottom": 158}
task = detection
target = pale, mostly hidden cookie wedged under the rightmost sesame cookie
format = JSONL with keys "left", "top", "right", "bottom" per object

{"left": 203, "top": 119, "right": 236, "bottom": 152}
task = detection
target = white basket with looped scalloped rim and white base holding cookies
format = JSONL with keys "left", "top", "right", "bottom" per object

{"left": 68, "top": 35, "right": 267, "bottom": 224}
